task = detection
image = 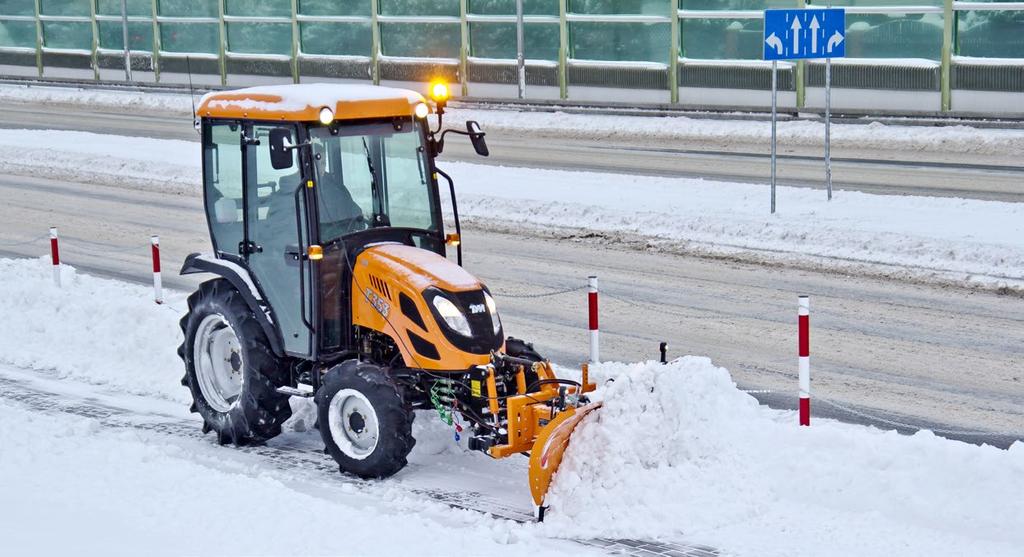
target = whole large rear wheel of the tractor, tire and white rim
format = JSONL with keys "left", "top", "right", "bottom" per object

{"left": 178, "top": 279, "right": 292, "bottom": 444}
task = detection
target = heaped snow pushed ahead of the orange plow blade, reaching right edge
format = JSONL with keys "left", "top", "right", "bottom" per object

{"left": 549, "top": 356, "right": 1024, "bottom": 556}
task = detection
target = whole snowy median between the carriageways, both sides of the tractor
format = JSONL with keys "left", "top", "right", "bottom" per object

{"left": 0, "top": 130, "right": 1024, "bottom": 288}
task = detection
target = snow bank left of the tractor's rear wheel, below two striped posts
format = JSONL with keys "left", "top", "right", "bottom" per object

{"left": 0, "top": 258, "right": 189, "bottom": 402}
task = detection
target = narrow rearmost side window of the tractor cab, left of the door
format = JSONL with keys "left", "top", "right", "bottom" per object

{"left": 203, "top": 122, "right": 244, "bottom": 255}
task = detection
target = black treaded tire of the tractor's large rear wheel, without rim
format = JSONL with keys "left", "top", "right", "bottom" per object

{"left": 178, "top": 279, "right": 292, "bottom": 445}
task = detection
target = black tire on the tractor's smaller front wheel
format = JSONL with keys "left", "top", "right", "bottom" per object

{"left": 315, "top": 360, "right": 416, "bottom": 479}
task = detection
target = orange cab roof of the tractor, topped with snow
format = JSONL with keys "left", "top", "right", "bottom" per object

{"left": 197, "top": 83, "right": 426, "bottom": 122}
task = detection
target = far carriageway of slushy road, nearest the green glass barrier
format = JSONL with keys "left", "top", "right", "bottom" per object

{"left": 0, "top": 102, "right": 1024, "bottom": 202}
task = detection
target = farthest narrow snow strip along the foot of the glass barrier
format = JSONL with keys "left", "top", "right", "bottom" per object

{"left": 0, "top": 85, "right": 1024, "bottom": 156}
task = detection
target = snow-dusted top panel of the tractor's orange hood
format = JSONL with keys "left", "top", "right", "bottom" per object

{"left": 356, "top": 244, "right": 483, "bottom": 292}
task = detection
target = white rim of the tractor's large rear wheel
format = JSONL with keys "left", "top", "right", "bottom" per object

{"left": 193, "top": 313, "right": 245, "bottom": 413}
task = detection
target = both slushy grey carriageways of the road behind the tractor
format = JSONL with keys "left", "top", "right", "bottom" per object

{"left": 0, "top": 100, "right": 1024, "bottom": 445}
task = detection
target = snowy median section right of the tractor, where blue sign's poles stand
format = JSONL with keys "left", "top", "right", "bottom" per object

{"left": 445, "top": 163, "right": 1024, "bottom": 287}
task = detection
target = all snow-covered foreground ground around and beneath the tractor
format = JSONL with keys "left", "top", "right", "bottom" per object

{"left": 0, "top": 258, "right": 1024, "bottom": 556}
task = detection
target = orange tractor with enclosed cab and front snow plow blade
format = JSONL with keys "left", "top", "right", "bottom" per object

{"left": 178, "top": 84, "right": 597, "bottom": 517}
